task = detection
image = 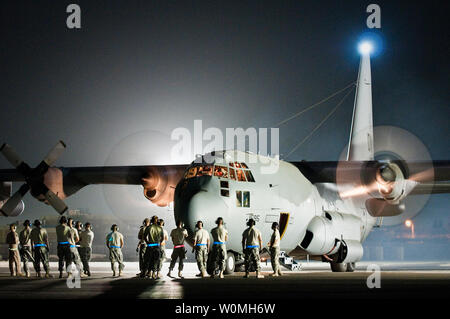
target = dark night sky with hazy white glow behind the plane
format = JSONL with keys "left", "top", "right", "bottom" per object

{"left": 0, "top": 0, "right": 450, "bottom": 250}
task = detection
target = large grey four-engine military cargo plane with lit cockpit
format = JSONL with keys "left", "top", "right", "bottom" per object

{"left": 0, "top": 42, "right": 450, "bottom": 273}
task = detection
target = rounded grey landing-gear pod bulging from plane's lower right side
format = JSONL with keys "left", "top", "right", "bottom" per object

{"left": 300, "top": 212, "right": 362, "bottom": 262}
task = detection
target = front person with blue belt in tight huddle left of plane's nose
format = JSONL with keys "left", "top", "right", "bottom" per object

{"left": 141, "top": 216, "right": 164, "bottom": 279}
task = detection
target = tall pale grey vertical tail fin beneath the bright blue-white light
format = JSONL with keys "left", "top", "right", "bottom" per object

{"left": 347, "top": 53, "right": 374, "bottom": 161}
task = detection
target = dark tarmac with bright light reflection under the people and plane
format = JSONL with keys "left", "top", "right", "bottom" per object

{"left": 0, "top": 262, "right": 450, "bottom": 301}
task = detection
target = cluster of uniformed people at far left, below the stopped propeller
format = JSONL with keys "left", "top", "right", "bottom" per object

{"left": 6, "top": 216, "right": 94, "bottom": 278}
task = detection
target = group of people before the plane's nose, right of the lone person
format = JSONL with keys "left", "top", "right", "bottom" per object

{"left": 136, "top": 216, "right": 282, "bottom": 279}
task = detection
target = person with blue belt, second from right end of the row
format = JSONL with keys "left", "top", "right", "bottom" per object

{"left": 242, "top": 218, "right": 264, "bottom": 278}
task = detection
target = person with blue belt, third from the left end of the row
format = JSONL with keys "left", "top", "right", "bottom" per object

{"left": 30, "top": 219, "right": 52, "bottom": 278}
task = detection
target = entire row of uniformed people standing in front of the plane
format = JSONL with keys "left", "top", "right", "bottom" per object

{"left": 6, "top": 216, "right": 282, "bottom": 279}
